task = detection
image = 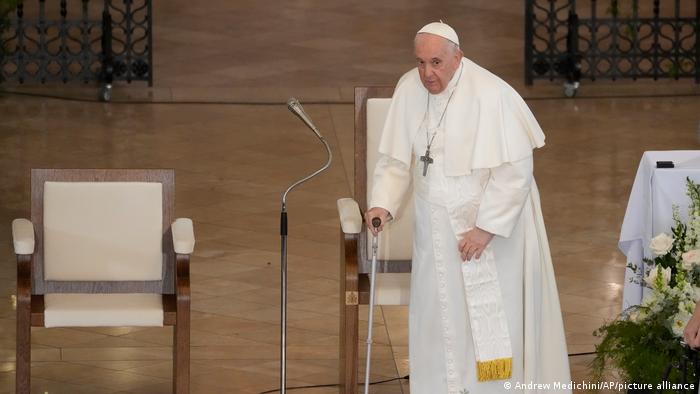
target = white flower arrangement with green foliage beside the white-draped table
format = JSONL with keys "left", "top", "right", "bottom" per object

{"left": 592, "top": 178, "right": 700, "bottom": 384}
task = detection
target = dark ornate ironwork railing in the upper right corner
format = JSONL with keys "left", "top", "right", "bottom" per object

{"left": 525, "top": 0, "right": 700, "bottom": 85}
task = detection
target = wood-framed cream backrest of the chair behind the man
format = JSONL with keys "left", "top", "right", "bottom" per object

{"left": 355, "top": 87, "right": 414, "bottom": 271}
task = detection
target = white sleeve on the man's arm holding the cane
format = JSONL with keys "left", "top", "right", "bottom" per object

{"left": 368, "top": 154, "right": 411, "bottom": 218}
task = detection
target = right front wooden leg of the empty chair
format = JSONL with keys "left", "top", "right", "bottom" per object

{"left": 173, "top": 254, "right": 190, "bottom": 394}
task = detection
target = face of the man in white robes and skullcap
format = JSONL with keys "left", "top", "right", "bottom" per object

{"left": 414, "top": 33, "right": 462, "bottom": 94}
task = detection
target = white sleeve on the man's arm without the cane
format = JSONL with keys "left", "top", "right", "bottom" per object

{"left": 476, "top": 156, "right": 533, "bottom": 238}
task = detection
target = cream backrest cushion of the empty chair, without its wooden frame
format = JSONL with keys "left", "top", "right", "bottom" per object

{"left": 43, "top": 182, "right": 163, "bottom": 281}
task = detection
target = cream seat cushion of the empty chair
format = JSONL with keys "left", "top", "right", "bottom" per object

{"left": 44, "top": 294, "right": 163, "bottom": 327}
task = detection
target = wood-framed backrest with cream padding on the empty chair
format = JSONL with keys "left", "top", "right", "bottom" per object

{"left": 31, "top": 169, "right": 175, "bottom": 294}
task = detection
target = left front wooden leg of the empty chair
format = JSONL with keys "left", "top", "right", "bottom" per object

{"left": 15, "top": 255, "right": 32, "bottom": 394}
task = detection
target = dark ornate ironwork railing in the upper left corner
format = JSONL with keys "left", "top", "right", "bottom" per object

{"left": 0, "top": 0, "right": 153, "bottom": 86}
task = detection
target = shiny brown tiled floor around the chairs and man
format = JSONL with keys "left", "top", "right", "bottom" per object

{"left": 0, "top": 0, "right": 700, "bottom": 394}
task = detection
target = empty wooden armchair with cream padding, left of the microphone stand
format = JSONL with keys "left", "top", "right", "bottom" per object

{"left": 12, "top": 169, "right": 194, "bottom": 394}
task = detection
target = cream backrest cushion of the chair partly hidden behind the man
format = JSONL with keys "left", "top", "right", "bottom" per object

{"left": 367, "top": 98, "right": 415, "bottom": 260}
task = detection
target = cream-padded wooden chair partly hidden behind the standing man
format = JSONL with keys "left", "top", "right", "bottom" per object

{"left": 338, "top": 87, "right": 414, "bottom": 393}
